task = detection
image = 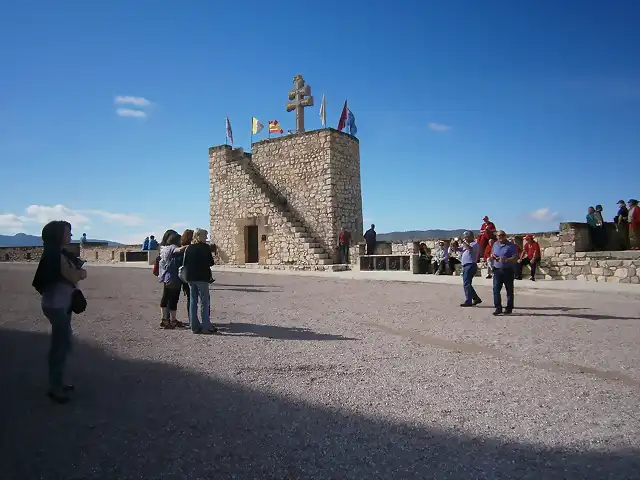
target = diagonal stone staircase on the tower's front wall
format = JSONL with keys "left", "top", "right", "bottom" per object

{"left": 238, "top": 159, "right": 333, "bottom": 265}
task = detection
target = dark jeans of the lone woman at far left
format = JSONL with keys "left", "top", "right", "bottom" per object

{"left": 42, "top": 307, "right": 72, "bottom": 393}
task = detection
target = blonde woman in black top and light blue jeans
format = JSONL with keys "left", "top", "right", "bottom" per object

{"left": 182, "top": 228, "right": 218, "bottom": 333}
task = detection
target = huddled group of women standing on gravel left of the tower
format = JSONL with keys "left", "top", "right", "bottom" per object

{"left": 154, "top": 228, "right": 218, "bottom": 334}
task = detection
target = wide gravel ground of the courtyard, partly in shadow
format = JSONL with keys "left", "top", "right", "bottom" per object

{"left": 0, "top": 264, "right": 640, "bottom": 480}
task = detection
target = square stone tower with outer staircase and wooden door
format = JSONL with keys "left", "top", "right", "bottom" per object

{"left": 209, "top": 128, "right": 362, "bottom": 268}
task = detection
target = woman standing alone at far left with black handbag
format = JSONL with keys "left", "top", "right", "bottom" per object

{"left": 32, "top": 221, "right": 87, "bottom": 403}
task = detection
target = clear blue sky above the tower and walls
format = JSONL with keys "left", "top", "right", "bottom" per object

{"left": 0, "top": 0, "right": 640, "bottom": 241}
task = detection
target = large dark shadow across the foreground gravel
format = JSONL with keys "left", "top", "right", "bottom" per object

{"left": 0, "top": 329, "right": 640, "bottom": 480}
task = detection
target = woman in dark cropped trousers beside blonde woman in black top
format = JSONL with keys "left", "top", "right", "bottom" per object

{"left": 158, "top": 230, "right": 186, "bottom": 329}
